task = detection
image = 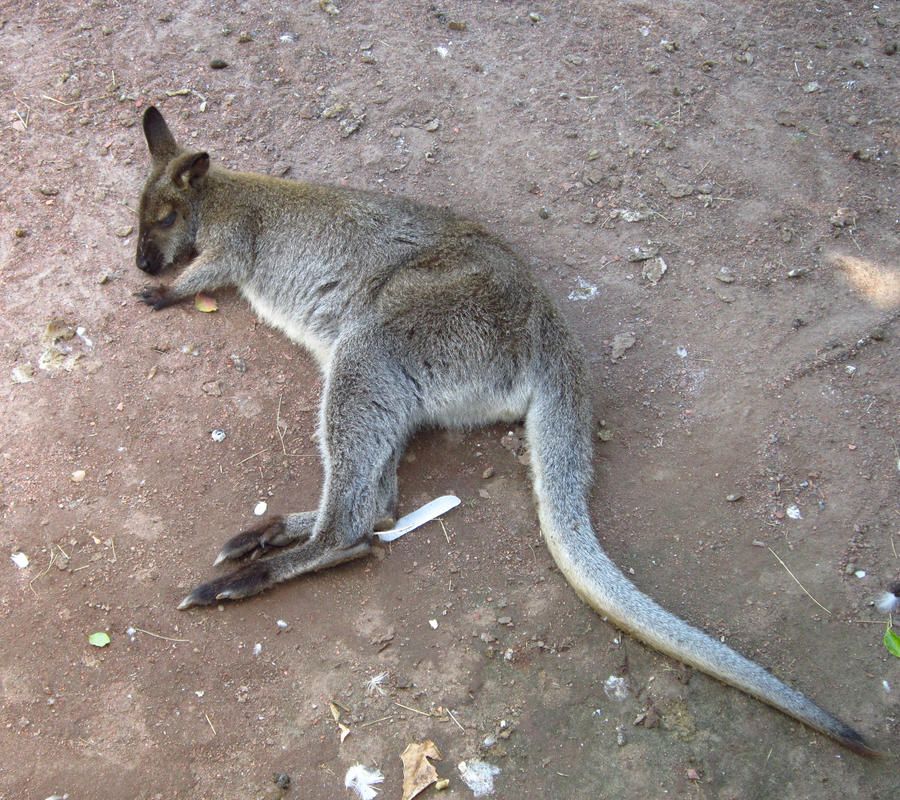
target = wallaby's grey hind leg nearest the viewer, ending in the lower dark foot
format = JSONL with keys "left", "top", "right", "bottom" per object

{"left": 178, "top": 340, "right": 413, "bottom": 609}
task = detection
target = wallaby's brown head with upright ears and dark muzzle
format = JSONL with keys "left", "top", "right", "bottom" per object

{"left": 136, "top": 106, "right": 209, "bottom": 275}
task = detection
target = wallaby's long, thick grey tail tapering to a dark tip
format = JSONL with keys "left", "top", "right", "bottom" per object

{"left": 526, "top": 356, "right": 880, "bottom": 756}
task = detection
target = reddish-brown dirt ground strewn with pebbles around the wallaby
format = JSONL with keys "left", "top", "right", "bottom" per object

{"left": 0, "top": 0, "right": 900, "bottom": 800}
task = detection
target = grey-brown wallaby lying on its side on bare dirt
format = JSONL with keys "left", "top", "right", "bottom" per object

{"left": 137, "top": 107, "right": 877, "bottom": 755}
